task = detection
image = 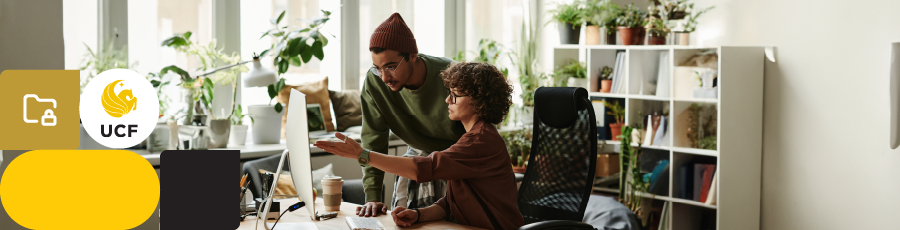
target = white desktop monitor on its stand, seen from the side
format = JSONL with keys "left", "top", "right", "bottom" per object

{"left": 256, "top": 89, "right": 316, "bottom": 229}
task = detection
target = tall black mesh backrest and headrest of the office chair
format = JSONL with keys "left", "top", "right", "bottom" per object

{"left": 519, "top": 87, "right": 597, "bottom": 229}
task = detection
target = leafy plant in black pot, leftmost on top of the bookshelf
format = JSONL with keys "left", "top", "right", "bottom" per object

{"left": 548, "top": 0, "right": 585, "bottom": 44}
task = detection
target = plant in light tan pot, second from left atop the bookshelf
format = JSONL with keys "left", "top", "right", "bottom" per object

{"left": 586, "top": 0, "right": 622, "bottom": 45}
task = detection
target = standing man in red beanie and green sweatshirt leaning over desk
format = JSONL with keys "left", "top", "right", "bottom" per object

{"left": 356, "top": 13, "right": 466, "bottom": 216}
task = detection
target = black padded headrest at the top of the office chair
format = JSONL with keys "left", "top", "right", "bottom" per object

{"left": 534, "top": 87, "right": 588, "bottom": 128}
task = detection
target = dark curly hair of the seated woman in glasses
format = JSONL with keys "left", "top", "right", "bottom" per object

{"left": 441, "top": 62, "right": 513, "bottom": 124}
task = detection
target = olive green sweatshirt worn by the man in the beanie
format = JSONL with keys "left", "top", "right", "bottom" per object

{"left": 360, "top": 54, "right": 466, "bottom": 202}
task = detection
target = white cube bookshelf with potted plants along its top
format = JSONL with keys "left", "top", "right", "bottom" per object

{"left": 553, "top": 45, "right": 765, "bottom": 230}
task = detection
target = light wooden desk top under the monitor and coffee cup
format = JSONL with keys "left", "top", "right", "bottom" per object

{"left": 238, "top": 198, "right": 480, "bottom": 230}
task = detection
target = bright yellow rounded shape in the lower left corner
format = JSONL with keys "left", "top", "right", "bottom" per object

{"left": 0, "top": 150, "right": 160, "bottom": 230}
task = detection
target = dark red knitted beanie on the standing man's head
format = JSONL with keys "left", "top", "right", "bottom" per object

{"left": 369, "top": 13, "right": 419, "bottom": 54}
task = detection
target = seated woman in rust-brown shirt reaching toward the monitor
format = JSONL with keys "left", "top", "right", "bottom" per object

{"left": 315, "top": 62, "right": 524, "bottom": 229}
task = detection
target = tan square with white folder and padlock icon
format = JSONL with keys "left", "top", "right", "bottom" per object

{"left": 0, "top": 70, "right": 81, "bottom": 150}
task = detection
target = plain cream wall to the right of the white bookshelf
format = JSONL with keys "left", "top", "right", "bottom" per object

{"left": 692, "top": 0, "right": 900, "bottom": 230}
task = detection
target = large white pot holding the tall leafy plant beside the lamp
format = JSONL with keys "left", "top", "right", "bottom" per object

{"left": 247, "top": 105, "right": 284, "bottom": 144}
